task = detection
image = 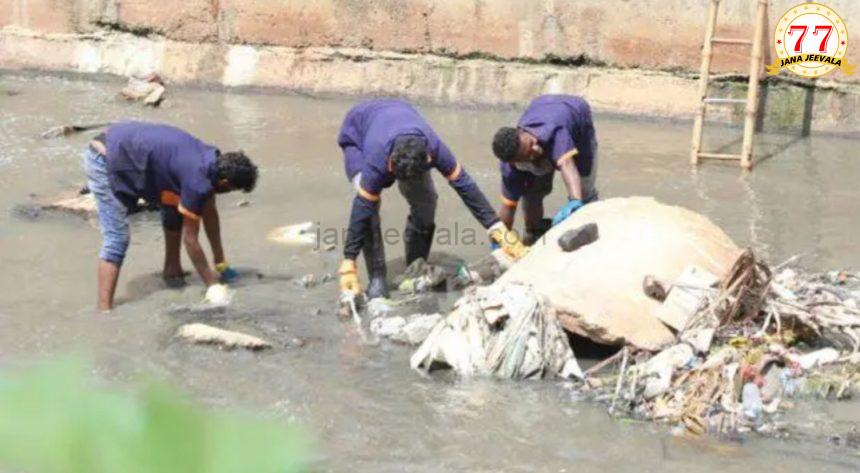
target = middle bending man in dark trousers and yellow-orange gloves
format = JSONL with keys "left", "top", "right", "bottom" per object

{"left": 337, "top": 100, "right": 526, "bottom": 299}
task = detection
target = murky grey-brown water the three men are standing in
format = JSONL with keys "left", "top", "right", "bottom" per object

{"left": 0, "top": 76, "right": 860, "bottom": 472}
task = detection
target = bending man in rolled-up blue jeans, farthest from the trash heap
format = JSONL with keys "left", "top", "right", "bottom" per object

{"left": 84, "top": 121, "right": 257, "bottom": 311}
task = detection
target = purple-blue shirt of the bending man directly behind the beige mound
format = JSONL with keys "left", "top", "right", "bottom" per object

{"left": 500, "top": 95, "right": 596, "bottom": 202}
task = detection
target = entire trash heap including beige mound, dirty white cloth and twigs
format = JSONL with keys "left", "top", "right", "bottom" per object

{"left": 404, "top": 197, "right": 860, "bottom": 434}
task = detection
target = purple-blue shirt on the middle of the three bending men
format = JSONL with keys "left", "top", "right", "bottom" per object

{"left": 337, "top": 100, "right": 460, "bottom": 201}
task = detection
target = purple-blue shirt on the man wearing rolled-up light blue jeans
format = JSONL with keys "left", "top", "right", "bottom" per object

{"left": 105, "top": 121, "right": 218, "bottom": 219}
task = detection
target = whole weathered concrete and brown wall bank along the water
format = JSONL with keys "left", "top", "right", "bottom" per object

{"left": 0, "top": 0, "right": 860, "bottom": 132}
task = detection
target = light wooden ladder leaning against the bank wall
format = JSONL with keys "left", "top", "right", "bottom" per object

{"left": 690, "top": 0, "right": 767, "bottom": 170}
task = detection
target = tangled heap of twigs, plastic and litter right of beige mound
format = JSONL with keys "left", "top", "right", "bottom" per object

{"left": 580, "top": 251, "right": 860, "bottom": 434}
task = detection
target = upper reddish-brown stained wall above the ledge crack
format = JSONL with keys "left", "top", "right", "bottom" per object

{"left": 0, "top": 0, "right": 860, "bottom": 81}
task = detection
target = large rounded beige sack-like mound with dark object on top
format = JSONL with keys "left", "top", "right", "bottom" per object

{"left": 496, "top": 197, "right": 740, "bottom": 350}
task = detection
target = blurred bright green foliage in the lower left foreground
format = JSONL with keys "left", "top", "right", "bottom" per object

{"left": 0, "top": 362, "right": 308, "bottom": 473}
